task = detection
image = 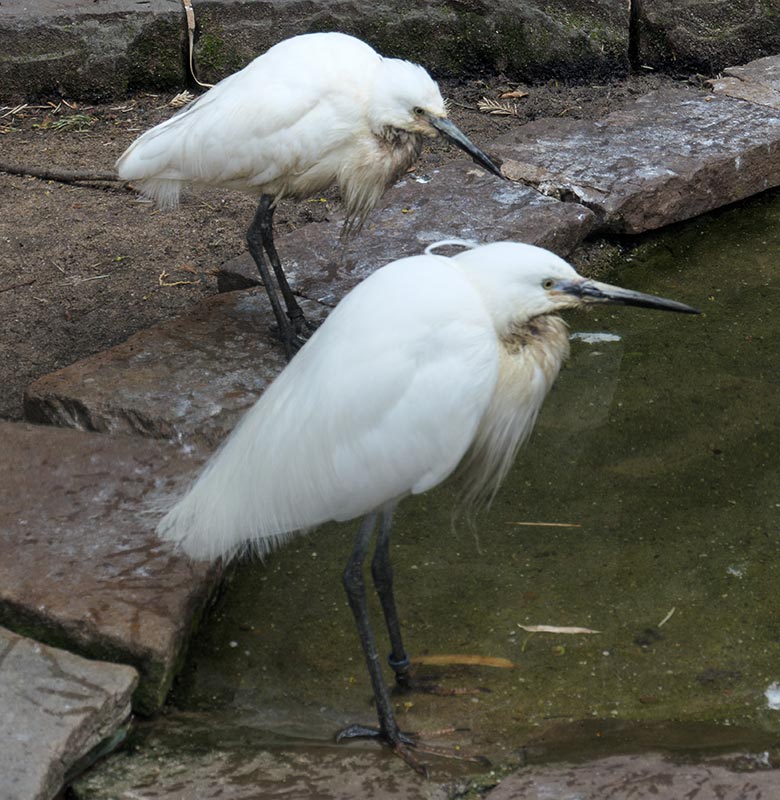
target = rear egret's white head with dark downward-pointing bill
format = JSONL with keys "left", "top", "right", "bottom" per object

{"left": 369, "top": 58, "right": 503, "bottom": 178}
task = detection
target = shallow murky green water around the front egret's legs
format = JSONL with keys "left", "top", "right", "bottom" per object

{"left": 168, "top": 188, "right": 780, "bottom": 763}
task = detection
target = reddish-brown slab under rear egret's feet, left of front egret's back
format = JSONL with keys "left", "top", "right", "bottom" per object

{"left": 25, "top": 289, "right": 325, "bottom": 449}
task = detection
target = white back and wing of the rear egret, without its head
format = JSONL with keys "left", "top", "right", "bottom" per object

{"left": 116, "top": 33, "right": 382, "bottom": 208}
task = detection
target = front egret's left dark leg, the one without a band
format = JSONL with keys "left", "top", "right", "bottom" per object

{"left": 343, "top": 512, "right": 402, "bottom": 745}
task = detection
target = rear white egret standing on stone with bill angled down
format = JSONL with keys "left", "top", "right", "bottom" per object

{"left": 116, "top": 33, "right": 501, "bottom": 358}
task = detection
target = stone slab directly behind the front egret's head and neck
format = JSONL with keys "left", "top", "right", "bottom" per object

{"left": 222, "top": 159, "right": 595, "bottom": 306}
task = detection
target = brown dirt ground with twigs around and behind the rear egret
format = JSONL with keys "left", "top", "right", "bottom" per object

{"left": 0, "top": 74, "right": 670, "bottom": 419}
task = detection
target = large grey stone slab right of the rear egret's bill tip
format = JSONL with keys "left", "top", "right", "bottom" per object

{"left": 490, "top": 88, "right": 780, "bottom": 238}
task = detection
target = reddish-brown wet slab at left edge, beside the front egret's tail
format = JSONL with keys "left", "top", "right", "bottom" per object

{"left": 0, "top": 422, "right": 219, "bottom": 716}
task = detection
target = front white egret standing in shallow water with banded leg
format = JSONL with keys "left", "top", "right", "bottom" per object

{"left": 158, "top": 242, "right": 697, "bottom": 764}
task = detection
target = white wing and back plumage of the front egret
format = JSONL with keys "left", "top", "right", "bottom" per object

{"left": 161, "top": 256, "right": 498, "bottom": 557}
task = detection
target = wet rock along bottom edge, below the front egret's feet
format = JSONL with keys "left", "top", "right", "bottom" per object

{"left": 73, "top": 717, "right": 454, "bottom": 800}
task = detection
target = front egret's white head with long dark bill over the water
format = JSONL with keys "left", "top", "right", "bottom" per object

{"left": 454, "top": 242, "right": 698, "bottom": 328}
